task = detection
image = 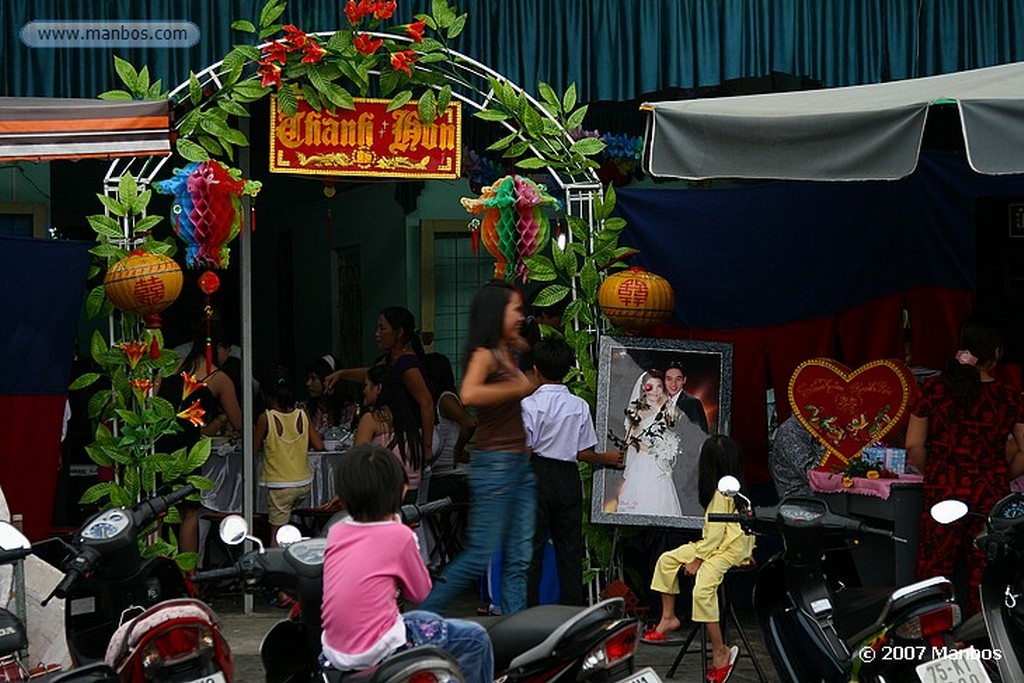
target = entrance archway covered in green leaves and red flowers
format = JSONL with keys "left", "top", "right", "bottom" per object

{"left": 73, "top": 0, "right": 632, "bottom": 581}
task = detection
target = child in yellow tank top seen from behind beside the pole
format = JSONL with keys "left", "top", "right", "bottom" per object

{"left": 253, "top": 368, "right": 324, "bottom": 548}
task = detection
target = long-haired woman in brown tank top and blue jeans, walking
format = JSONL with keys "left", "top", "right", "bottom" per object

{"left": 421, "top": 281, "right": 537, "bottom": 614}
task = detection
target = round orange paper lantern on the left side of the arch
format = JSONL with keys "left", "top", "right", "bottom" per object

{"left": 103, "top": 250, "right": 182, "bottom": 328}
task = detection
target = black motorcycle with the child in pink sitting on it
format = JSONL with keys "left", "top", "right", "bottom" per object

{"left": 195, "top": 499, "right": 638, "bottom": 683}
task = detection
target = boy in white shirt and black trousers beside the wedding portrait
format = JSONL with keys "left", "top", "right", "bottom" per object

{"left": 522, "top": 339, "right": 623, "bottom": 605}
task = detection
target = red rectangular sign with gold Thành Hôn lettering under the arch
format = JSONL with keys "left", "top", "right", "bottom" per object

{"left": 270, "top": 97, "right": 462, "bottom": 179}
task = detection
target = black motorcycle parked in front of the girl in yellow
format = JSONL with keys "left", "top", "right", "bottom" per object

{"left": 708, "top": 476, "right": 966, "bottom": 683}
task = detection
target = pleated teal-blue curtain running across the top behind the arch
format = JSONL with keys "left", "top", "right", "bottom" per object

{"left": 6, "top": 0, "right": 1024, "bottom": 101}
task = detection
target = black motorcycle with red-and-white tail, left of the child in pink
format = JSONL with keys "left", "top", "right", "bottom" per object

{"left": 43, "top": 485, "right": 233, "bottom": 683}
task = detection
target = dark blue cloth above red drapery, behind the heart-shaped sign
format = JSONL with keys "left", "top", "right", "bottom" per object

{"left": 616, "top": 153, "right": 1024, "bottom": 329}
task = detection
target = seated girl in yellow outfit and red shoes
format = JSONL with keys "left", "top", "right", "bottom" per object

{"left": 644, "top": 435, "right": 754, "bottom": 683}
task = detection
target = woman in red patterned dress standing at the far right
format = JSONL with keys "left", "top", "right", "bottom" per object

{"left": 906, "top": 319, "right": 1024, "bottom": 613}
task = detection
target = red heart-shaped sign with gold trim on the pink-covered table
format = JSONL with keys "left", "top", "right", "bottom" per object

{"left": 790, "top": 358, "right": 915, "bottom": 469}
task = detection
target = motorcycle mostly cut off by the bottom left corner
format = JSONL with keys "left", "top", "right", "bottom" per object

{"left": 0, "top": 521, "right": 118, "bottom": 683}
